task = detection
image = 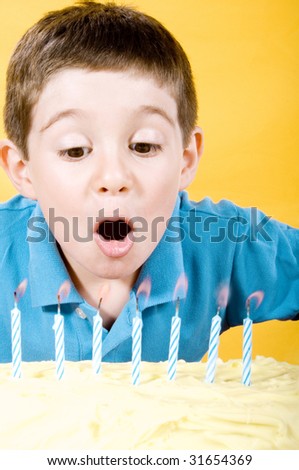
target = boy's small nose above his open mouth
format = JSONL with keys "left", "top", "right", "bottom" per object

{"left": 98, "top": 149, "right": 132, "bottom": 195}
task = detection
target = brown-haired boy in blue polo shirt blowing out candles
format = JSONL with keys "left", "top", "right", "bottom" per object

{"left": 0, "top": 2, "right": 299, "bottom": 362}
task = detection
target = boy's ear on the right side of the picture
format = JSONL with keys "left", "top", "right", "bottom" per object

{"left": 179, "top": 126, "right": 203, "bottom": 191}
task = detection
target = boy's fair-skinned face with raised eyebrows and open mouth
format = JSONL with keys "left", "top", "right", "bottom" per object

{"left": 22, "top": 69, "right": 198, "bottom": 282}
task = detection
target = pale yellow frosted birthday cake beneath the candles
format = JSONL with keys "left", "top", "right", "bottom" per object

{"left": 0, "top": 357, "right": 299, "bottom": 450}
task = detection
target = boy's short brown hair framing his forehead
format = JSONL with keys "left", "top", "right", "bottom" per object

{"left": 4, "top": 2, "right": 197, "bottom": 159}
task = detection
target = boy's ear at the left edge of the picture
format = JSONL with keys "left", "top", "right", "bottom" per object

{"left": 0, "top": 139, "right": 36, "bottom": 199}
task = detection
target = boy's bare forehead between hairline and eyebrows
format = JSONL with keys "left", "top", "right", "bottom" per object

{"left": 32, "top": 69, "right": 178, "bottom": 127}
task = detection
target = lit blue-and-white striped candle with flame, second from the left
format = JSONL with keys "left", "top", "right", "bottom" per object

{"left": 53, "top": 281, "right": 71, "bottom": 380}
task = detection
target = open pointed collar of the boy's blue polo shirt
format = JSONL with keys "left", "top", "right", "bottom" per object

{"left": 27, "top": 196, "right": 185, "bottom": 310}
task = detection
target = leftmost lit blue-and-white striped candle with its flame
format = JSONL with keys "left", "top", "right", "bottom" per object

{"left": 10, "top": 279, "right": 27, "bottom": 379}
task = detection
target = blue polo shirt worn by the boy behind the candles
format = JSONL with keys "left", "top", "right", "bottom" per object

{"left": 0, "top": 192, "right": 299, "bottom": 362}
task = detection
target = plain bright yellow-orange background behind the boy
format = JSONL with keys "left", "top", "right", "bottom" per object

{"left": 0, "top": 0, "right": 299, "bottom": 363}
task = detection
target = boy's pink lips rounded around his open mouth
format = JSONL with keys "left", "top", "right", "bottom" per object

{"left": 93, "top": 217, "right": 134, "bottom": 258}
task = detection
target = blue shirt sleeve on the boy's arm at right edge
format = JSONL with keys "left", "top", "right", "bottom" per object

{"left": 226, "top": 208, "right": 299, "bottom": 326}
